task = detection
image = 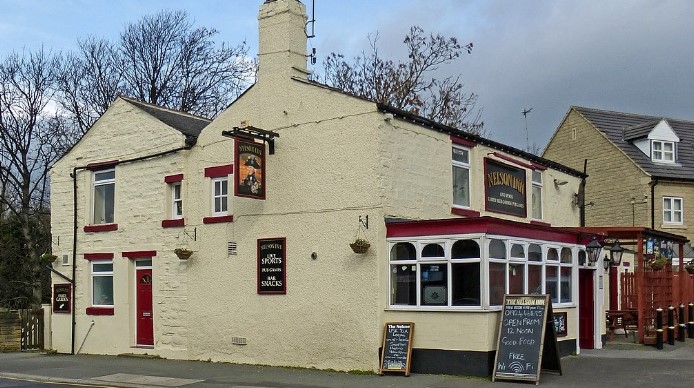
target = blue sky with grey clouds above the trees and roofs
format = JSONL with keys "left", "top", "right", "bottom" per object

{"left": 0, "top": 0, "right": 694, "bottom": 148}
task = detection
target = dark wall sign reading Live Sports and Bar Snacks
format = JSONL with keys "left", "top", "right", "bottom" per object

{"left": 258, "top": 237, "right": 287, "bottom": 294}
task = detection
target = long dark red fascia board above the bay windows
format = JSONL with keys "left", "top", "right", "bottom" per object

{"left": 386, "top": 216, "right": 580, "bottom": 244}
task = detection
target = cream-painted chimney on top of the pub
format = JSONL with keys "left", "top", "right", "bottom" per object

{"left": 258, "top": 0, "right": 309, "bottom": 83}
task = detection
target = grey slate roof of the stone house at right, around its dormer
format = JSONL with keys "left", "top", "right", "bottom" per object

{"left": 571, "top": 106, "right": 694, "bottom": 181}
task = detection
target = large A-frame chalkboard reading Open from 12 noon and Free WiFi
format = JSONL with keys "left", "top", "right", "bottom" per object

{"left": 492, "top": 295, "right": 561, "bottom": 385}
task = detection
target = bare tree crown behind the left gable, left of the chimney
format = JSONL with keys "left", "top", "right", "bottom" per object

{"left": 59, "top": 11, "right": 256, "bottom": 132}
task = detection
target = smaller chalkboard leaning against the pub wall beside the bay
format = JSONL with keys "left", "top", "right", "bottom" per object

{"left": 381, "top": 322, "right": 414, "bottom": 376}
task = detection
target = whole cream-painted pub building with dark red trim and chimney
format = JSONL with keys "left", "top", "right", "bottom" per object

{"left": 51, "top": 0, "right": 616, "bottom": 376}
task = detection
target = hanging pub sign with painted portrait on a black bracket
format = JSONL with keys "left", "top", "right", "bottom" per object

{"left": 234, "top": 139, "right": 265, "bottom": 199}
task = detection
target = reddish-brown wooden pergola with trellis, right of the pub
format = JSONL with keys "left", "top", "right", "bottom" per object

{"left": 580, "top": 226, "right": 694, "bottom": 343}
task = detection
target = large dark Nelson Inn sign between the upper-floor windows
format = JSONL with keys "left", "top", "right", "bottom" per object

{"left": 484, "top": 159, "right": 527, "bottom": 217}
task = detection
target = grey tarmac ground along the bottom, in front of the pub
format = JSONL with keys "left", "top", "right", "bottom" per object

{"left": 0, "top": 339, "right": 694, "bottom": 388}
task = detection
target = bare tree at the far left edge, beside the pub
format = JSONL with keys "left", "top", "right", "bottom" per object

{"left": 0, "top": 48, "right": 66, "bottom": 303}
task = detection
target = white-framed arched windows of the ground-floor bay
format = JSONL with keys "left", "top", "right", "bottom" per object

{"left": 389, "top": 237, "right": 578, "bottom": 309}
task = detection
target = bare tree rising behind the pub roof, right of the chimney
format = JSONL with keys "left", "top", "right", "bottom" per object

{"left": 319, "top": 26, "right": 484, "bottom": 134}
